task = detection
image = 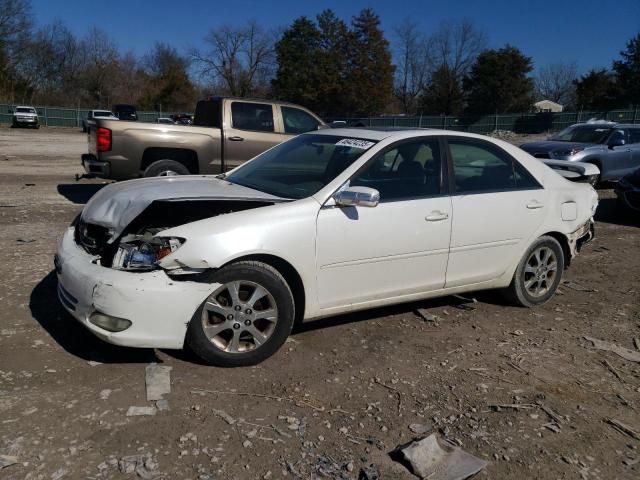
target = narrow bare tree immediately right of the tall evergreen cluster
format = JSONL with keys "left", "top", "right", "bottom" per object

{"left": 394, "top": 18, "right": 428, "bottom": 113}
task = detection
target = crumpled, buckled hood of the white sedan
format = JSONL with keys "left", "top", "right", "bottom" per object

{"left": 82, "top": 175, "right": 283, "bottom": 242}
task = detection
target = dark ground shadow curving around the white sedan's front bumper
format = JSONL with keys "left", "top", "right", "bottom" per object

{"left": 29, "top": 271, "right": 161, "bottom": 363}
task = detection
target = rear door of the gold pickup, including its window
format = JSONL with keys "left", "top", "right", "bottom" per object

{"left": 224, "top": 100, "right": 283, "bottom": 170}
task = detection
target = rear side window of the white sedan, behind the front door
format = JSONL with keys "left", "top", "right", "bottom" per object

{"left": 449, "top": 140, "right": 540, "bottom": 193}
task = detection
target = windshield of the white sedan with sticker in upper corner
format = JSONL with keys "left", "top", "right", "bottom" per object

{"left": 226, "top": 134, "right": 376, "bottom": 200}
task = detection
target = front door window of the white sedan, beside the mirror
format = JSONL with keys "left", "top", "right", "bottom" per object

{"left": 350, "top": 138, "right": 441, "bottom": 202}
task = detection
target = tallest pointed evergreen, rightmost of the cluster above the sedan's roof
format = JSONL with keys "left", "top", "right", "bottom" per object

{"left": 345, "top": 8, "right": 395, "bottom": 116}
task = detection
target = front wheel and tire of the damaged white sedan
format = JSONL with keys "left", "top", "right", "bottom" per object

{"left": 185, "top": 261, "right": 295, "bottom": 367}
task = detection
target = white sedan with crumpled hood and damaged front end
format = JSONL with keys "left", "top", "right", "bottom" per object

{"left": 55, "top": 129, "right": 598, "bottom": 366}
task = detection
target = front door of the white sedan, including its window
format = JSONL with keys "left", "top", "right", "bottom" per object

{"left": 317, "top": 137, "right": 451, "bottom": 308}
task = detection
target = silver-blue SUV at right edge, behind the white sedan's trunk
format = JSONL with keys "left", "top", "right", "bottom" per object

{"left": 520, "top": 122, "right": 640, "bottom": 183}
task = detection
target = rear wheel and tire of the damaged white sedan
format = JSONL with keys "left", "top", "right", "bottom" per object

{"left": 504, "top": 236, "right": 565, "bottom": 307}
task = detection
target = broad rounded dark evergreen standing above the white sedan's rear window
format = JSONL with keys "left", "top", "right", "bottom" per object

{"left": 463, "top": 45, "right": 534, "bottom": 114}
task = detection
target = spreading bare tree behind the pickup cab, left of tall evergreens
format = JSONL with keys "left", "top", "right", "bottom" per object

{"left": 191, "top": 21, "right": 274, "bottom": 97}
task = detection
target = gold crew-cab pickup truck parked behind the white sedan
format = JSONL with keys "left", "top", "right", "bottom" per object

{"left": 82, "top": 97, "right": 327, "bottom": 180}
